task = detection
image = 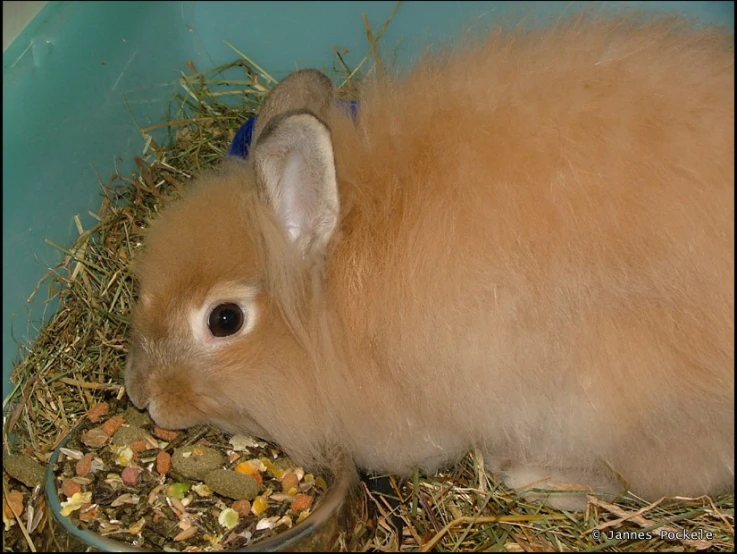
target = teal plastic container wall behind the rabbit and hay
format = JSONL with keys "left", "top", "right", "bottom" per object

{"left": 3, "top": 2, "right": 734, "bottom": 398}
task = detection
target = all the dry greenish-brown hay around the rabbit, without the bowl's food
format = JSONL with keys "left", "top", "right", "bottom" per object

{"left": 3, "top": 3, "right": 734, "bottom": 551}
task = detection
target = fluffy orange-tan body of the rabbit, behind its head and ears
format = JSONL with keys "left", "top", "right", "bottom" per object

{"left": 328, "top": 12, "right": 734, "bottom": 490}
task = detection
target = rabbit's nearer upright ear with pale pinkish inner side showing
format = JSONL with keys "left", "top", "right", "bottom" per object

{"left": 253, "top": 112, "right": 339, "bottom": 257}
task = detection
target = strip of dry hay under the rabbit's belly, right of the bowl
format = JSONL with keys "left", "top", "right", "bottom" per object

{"left": 341, "top": 453, "right": 734, "bottom": 552}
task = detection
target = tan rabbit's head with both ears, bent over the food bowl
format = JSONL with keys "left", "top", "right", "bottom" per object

{"left": 125, "top": 71, "right": 339, "bottom": 462}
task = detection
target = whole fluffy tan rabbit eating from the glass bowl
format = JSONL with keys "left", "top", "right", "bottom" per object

{"left": 126, "top": 10, "right": 734, "bottom": 508}
